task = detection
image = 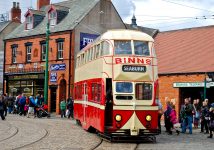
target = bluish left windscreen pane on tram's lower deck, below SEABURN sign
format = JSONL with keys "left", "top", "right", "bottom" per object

{"left": 116, "top": 82, "right": 133, "bottom": 93}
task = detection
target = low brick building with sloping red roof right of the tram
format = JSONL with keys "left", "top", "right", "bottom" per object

{"left": 155, "top": 26, "right": 214, "bottom": 113}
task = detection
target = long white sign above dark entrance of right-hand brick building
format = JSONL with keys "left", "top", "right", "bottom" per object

{"left": 173, "top": 82, "right": 214, "bottom": 88}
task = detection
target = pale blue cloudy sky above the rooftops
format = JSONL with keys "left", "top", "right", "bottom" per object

{"left": 0, "top": 0, "right": 214, "bottom": 31}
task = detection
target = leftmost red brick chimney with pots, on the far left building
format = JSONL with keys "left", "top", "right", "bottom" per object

{"left": 11, "top": 2, "right": 21, "bottom": 23}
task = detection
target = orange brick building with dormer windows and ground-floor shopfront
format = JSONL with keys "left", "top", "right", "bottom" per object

{"left": 4, "top": 0, "right": 126, "bottom": 113}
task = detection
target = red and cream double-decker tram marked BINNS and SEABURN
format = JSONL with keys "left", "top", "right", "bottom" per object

{"left": 74, "top": 29, "right": 159, "bottom": 141}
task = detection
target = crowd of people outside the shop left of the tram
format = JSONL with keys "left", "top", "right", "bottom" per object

{"left": 0, "top": 93, "right": 73, "bottom": 120}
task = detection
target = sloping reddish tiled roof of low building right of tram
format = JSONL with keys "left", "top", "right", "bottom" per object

{"left": 155, "top": 26, "right": 214, "bottom": 74}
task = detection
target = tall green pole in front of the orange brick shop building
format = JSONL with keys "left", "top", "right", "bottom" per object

{"left": 44, "top": 21, "right": 50, "bottom": 104}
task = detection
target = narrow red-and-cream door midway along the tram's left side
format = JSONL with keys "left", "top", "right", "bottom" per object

{"left": 82, "top": 83, "right": 88, "bottom": 124}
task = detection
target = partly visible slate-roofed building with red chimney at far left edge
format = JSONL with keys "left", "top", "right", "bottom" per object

{"left": 0, "top": 2, "right": 21, "bottom": 92}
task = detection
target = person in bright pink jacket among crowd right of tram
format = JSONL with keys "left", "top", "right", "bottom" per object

{"left": 169, "top": 104, "right": 180, "bottom": 135}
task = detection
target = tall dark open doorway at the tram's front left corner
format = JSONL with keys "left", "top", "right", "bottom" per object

{"left": 105, "top": 78, "right": 113, "bottom": 127}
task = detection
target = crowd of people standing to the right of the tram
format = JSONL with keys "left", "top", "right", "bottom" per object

{"left": 159, "top": 98, "right": 214, "bottom": 138}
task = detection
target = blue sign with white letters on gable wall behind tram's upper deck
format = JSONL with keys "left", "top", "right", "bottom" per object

{"left": 80, "top": 33, "right": 99, "bottom": 50}
